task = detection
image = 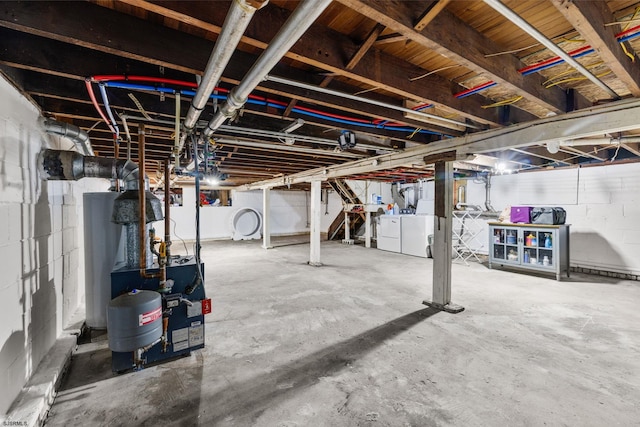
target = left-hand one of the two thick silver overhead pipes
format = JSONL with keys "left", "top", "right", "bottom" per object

{"left": 180, "top": 0, "right": 269, "bottom": 142}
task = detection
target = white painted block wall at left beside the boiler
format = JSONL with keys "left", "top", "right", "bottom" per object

{"left": 0, "top": 77, "right": 108, "bottom": 414}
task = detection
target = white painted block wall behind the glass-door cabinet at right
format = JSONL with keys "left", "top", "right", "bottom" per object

{"left": 467, "top": 163, "right": 640, "bottom": 275}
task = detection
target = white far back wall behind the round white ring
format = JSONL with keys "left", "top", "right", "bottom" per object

{"left": 168, "top": 187, "right": 342, "bottom": 244}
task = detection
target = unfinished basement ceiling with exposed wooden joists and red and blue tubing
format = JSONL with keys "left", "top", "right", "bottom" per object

{"left": 0, "top": 0, "right": 640, "bottom": 186}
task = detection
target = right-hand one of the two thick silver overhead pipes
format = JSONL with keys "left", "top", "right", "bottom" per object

{"left": 204, "top": 0, "right": 332, "bottom": 137}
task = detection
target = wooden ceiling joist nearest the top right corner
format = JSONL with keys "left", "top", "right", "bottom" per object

{"left": 551, "top": 0, "right": 640, "bottom": 96}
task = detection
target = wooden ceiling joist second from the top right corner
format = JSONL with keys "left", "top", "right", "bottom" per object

{"left": 336, "top": 0, "right": 591, "bottom": 113}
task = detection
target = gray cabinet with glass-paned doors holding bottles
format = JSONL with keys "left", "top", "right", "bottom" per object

{"left": 489, "top": 222, "right": 570, "bottom": 280}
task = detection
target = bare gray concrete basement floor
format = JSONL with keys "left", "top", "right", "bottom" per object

{"left": 47, "top": 238, "right": 640, "bottom": 426}
